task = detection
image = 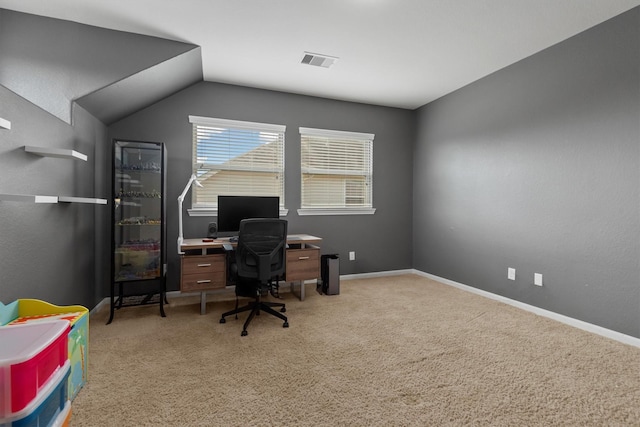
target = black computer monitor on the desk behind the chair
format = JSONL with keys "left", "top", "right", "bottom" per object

{"left": 218, "top": 196, "right": 280, "bottom": 234}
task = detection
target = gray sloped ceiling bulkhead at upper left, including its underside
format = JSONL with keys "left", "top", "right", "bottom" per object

{"left": 0, "top": 9, "right": 202, "bottom": 124}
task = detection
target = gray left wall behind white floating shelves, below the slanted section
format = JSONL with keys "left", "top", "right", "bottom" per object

{"left": 0, "top": 86, "right": 109, "bottom": 308}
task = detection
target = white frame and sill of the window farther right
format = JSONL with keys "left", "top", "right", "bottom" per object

{"left": 297, "top": 127, "right": 376, "bottom": 216}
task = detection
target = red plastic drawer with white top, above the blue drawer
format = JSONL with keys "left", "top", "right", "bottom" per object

{"left": 0, "top": 320, "right": 69, "bottom": 419}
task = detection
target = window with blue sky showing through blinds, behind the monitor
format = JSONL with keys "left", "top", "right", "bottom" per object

{"left": 189, "top": 116, "right": 286, "bottom": 216}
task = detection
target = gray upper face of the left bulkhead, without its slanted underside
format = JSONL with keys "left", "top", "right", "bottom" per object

{"left": 0, "top": 9, "right": 194, "bottom": 123}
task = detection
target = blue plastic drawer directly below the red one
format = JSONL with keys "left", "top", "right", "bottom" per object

{"left": 0, "top": 359, "right": 71, "bottom": 427}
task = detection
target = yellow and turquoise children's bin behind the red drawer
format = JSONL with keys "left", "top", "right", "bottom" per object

{"left": 0, "top": 299, "right": 89, "bottom": 400}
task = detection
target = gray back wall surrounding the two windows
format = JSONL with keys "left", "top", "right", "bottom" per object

{"left": 109, "top": 82, "right": 415, "bottom": 290}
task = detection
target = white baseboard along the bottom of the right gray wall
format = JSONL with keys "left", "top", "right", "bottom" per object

{"left": 412, "top": 270, "right": 640, "bottom": 348}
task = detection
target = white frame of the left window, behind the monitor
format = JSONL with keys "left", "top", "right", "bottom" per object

{"left": 187, "top": 115, "right": 288, "bottom": 216}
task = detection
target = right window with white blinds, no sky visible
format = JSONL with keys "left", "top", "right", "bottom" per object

{"left": 298, "top": 128, "right": 375, "bottom": 215}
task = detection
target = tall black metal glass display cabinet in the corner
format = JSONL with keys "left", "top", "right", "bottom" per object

{"left": 107, "top": 139, "right": 167, "bottom": 324}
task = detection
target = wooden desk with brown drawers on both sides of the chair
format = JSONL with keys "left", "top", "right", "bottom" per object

{"left": 180, "top": 234, "right": 322, "bottom": 314}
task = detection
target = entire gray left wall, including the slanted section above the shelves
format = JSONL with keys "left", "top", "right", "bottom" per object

{"left": 0, "top": 9, "right": 193, "bottom": 308}
